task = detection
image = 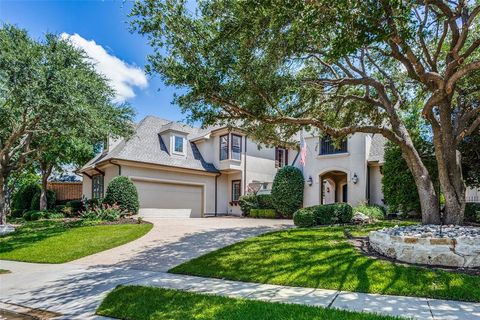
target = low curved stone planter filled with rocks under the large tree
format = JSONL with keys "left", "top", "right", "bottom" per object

{"left": 369, "top": 225, "right": 480, "bottom": 268}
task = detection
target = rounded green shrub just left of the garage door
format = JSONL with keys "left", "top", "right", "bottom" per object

{"left": 103, "top": 176, "right": 139, "bottom": 214}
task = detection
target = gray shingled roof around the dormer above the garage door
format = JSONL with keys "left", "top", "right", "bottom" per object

{"left": 82, "top": 116, "right": 218, "bottom": 173}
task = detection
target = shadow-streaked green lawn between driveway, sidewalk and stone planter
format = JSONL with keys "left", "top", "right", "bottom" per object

{"left": 170, "top": 222, "right": 480, "bottom": 302}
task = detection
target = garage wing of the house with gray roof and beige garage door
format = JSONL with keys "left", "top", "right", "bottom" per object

{"left": 79, "top": 116, "right": 297, "bottom": 217}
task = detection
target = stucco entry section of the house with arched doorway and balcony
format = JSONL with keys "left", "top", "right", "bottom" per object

{"left": 295, "top": 133, "right": 385, "bottom": 206}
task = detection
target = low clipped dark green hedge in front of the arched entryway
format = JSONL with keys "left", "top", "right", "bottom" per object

{"left": 293, "top": 203, "right": 353, "bottom": 227}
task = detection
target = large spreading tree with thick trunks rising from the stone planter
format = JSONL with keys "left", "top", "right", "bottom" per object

{"left": 131, "top": 0, "right": 480, "bottom": 224}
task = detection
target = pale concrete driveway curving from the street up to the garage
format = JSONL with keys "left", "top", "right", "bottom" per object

{"left": 0, "top": 217, "right": 292, "bottom": 319}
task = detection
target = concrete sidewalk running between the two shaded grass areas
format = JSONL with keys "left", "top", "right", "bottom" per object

{"left": 130, "top": 273, "right": 480, "bottom": 320}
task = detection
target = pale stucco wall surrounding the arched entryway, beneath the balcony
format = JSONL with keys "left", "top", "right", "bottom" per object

{"left": 303, "top": 134, "right": 367, "bottom": 206}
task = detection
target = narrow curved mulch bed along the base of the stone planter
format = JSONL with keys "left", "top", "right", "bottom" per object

{"left": 344, "top": 230, "right": 480, "bottom": 276}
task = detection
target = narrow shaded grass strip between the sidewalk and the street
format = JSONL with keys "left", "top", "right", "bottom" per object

{"left": 97, "top": 286, "right": 399, "bottom": 320}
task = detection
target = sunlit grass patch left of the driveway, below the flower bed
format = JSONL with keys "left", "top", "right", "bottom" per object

{"left": 0, "top": 220, "right": 152, "bottom": 263}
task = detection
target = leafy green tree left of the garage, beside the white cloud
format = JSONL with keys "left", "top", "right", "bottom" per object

{"left": 0, "top": 25, "right": 132, "bottom": 224}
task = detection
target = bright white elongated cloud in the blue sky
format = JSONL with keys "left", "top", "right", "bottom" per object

{"left": 60, "top": 33, "right": 148, "bottom": 102}
